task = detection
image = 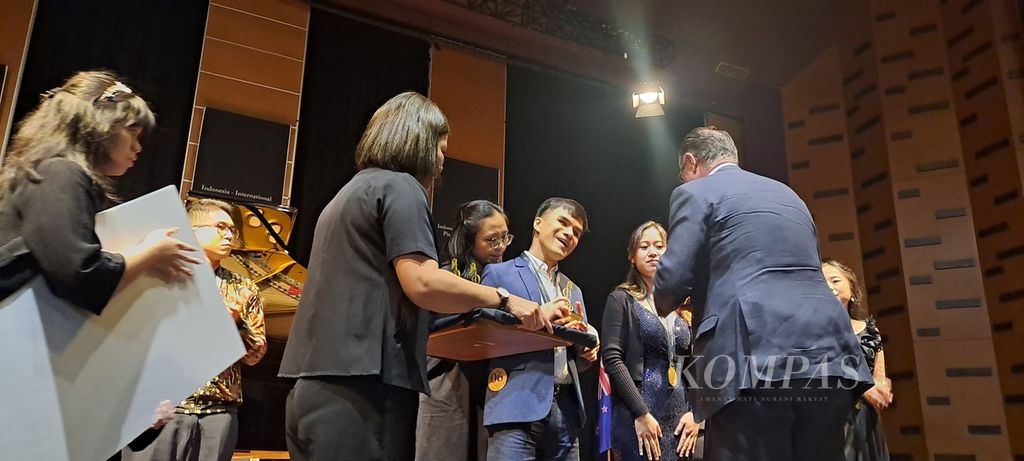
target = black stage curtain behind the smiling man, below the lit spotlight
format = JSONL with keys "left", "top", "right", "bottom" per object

{"left": 505, "top": 65, "right": 702, "bottom": 459}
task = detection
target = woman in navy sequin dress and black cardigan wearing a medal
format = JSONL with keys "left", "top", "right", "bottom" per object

{"left": 601, "top": 221, "right": 698, "bottom": 460}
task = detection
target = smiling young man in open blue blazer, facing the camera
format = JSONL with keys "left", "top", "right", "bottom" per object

{"left": 480, "top": 198, "right": 598, "bottom": 461}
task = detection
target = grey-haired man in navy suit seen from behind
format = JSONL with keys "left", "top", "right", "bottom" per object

{"left": 654, "top": 127, "right": 871, "bottom": 461}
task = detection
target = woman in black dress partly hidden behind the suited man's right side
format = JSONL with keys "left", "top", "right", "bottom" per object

{"left": 821, "top": 259, "right": 893, "bottom": 461}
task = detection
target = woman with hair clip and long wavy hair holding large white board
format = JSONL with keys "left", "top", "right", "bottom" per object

{"left": 0, "top": 72, "right": 201, "bottom": 315}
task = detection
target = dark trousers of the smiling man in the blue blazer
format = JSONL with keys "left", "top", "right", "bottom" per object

{"left": 487, "top": 385, "right": 582, "bottom": 461}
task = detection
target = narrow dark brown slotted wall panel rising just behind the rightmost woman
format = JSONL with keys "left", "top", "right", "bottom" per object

{"left": 840, "top": 13, "right": 930, "bottom": 452}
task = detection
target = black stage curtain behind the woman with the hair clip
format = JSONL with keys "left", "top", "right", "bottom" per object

{"left": 14, "top": 0, "right": 209, "bottom": 200}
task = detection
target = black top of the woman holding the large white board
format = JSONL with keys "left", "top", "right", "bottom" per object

{"left": 0, "top": 157, "right": 125, "bottom": 313}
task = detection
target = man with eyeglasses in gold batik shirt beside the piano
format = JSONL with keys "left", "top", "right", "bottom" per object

{"left": 121, "top": 199, "right": 266, "bottom": 461}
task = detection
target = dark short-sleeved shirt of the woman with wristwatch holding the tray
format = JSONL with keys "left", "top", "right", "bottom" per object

{"left": 280, "top": 168, "right": 437, "bottom": 392}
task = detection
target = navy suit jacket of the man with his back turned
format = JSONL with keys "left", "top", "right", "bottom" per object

{"left": 654, "top": 165, "right": 872, "bottom": 420}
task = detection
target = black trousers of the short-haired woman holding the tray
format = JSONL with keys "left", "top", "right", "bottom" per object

{"left": 285, "top": 376, "right": 418, "bottom": 461}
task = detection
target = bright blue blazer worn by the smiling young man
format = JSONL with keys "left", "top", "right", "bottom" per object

{"left": 480, "top": 254, "right": 589, "bottom": 427}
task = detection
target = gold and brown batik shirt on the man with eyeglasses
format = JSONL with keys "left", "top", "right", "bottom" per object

{"left": 175, "top": 267, "right": 266, "bottom": 415}
